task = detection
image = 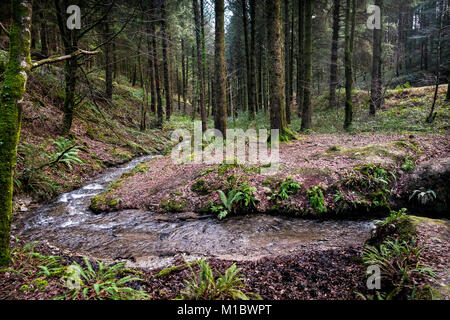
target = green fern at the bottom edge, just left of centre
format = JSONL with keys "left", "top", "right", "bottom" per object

{"left": 178, "top": 259, "right": 261, "bottom": 300}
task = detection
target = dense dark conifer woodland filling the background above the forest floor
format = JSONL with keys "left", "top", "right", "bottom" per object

{"left": 0, "top": 0, "right": 450, "bottom": 132}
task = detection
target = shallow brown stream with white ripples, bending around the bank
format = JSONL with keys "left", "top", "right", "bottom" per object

{"left": 13, "top": 156, "right": 373, "bottom": 268}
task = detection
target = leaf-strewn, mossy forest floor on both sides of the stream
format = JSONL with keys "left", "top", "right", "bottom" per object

{"left": 0, "top": 58, "right": 450, "bottom": 299}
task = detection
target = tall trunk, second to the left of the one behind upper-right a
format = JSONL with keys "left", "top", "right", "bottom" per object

{"left": 330, "top": 0, "right": 341, "bottom": 108}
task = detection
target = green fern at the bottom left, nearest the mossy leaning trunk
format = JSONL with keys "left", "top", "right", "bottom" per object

{"left": 59, "top": 257, "right": 150, "bottom": 300}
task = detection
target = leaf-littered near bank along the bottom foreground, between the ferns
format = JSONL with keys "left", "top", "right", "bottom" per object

{"left": 0, "top": 218, "right": 450, "bottom": 300}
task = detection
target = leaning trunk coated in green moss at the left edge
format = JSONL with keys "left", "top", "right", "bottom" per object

{"left": 0, "top": 0, "right": 32, "bottom": 266}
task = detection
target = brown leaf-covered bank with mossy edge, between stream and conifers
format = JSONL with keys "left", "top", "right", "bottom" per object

{"left": 91, "top": 134, "right": 450, "bottom": 218}
